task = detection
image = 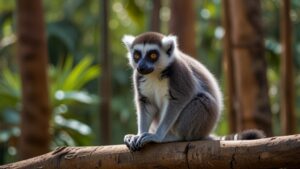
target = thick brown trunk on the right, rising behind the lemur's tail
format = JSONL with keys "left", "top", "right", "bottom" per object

{"left": 229, "top": 0, "right": 272, "bottom": 136}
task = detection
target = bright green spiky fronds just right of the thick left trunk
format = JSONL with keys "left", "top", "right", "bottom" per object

{"left": 49, "top": 56, "right": 100, "bottom": 145}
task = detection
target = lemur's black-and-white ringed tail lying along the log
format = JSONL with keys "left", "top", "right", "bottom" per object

{"left": 217, "top": 129, "right": 266, "bottom": 140}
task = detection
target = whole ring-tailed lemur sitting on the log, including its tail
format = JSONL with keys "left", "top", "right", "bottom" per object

{"left": 123, "top": 32, "right": 263, "bottom": 151}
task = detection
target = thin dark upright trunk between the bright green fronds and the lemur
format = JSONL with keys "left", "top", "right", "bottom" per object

{"left": 99, "top": 0, "right": 111, "bottom": 145}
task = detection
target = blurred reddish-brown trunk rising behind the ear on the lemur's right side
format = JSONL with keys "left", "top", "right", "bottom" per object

{"left": 169, "top": 0, "right": 196, "bottom": 57}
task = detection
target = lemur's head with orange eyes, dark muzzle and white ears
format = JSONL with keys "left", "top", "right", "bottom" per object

{"left": 122, "top": 32, "right": 177, "bottom": 75}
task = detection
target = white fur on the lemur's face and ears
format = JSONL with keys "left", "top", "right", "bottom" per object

{"left": 122, "top": 35, "right": 177, "bottom": 72}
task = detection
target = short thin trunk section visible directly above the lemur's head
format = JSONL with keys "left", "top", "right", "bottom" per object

{"left": 150, "top": 0, "right": 161, "bottom": 32}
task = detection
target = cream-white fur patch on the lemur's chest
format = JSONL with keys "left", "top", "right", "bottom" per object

{"left": 140, "top": 75, "right": 169, "bottom": 108}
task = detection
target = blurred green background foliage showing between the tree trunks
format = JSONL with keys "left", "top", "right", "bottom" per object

{"left": 0, "top": 0, "right": 300, "bottom": 164}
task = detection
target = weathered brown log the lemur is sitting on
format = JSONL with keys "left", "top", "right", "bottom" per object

{"left": 0, "top": 135, "right": 300, "bottom": 169}
